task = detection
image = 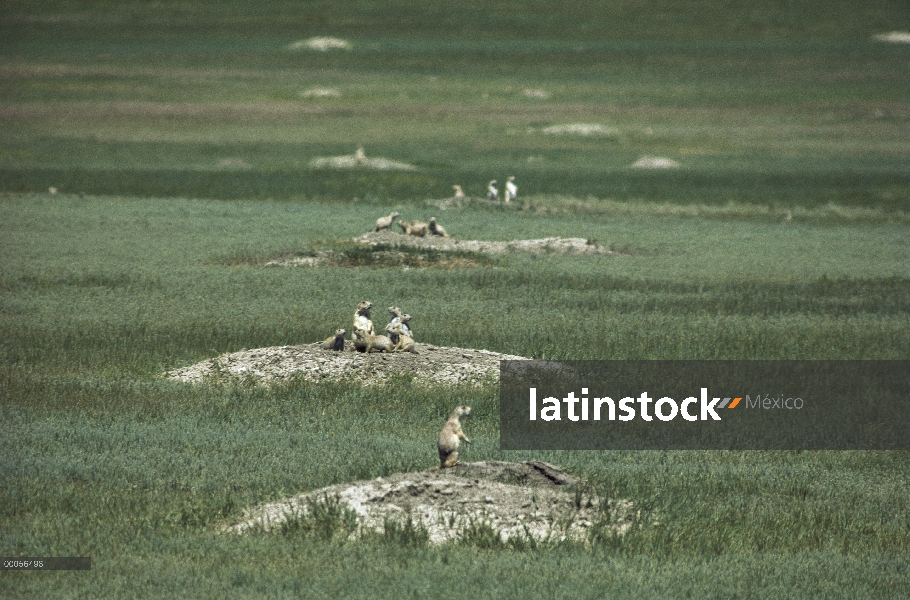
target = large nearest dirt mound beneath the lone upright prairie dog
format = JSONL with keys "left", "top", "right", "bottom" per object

{"left": 224, "top": 461, "right": 640, "bottom": 544}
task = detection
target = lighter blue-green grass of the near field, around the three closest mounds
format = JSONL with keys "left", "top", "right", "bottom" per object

{"left": 0, "top": 194, "right": 910, "bottom": 597}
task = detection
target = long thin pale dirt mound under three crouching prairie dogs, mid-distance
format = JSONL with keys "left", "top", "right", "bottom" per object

{"left": 354, "top": 230, "right": 615, "bottom": 254}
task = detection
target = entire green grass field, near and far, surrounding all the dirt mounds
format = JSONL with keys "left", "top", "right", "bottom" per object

{"left": 0, "top": 0, "right": 910, "bottom": 598}
